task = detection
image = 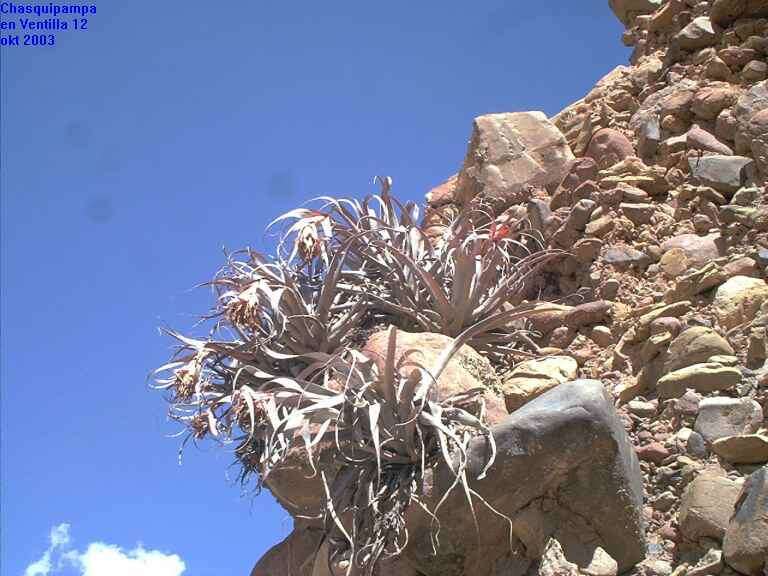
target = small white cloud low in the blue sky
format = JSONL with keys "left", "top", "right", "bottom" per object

{"left": 24, "top": 524, "right": 186, "bottom": 576}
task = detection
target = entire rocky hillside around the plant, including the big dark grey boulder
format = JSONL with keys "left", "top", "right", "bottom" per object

{"left": 253, "top": 0, "right": 768, "bottom": 576}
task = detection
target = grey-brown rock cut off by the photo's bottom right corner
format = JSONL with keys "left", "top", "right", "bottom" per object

{"left": 723, "top": 466, "right": 768, "bottom": 576}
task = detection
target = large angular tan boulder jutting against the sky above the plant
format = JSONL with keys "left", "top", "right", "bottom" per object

{"left": 455, "top": 112, "right": 574, "bottom": 206}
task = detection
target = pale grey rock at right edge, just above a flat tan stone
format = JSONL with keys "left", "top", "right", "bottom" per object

{"left": 693, "top": 396, "right": 763, "bottom": 443}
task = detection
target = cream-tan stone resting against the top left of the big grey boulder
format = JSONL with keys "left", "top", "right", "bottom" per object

{"left": 502, "top": 356, "right": 579, "bottom": 413}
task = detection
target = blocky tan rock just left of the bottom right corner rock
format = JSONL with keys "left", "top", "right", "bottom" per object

{"left": 679, "top": 472, "right": 740, "bottom": 542}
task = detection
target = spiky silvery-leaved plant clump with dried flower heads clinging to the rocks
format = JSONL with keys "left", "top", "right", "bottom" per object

{"left": 155, "top": 178, "right": 562, "bottom": 574}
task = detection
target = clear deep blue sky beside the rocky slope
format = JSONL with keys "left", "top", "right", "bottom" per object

{"left": 0, "top": 0, "right": 628, "bottom": 576}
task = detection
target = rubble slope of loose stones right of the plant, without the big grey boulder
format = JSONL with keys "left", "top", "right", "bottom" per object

{"left": 420, "top": 0, "right": 768, "bottom": 576}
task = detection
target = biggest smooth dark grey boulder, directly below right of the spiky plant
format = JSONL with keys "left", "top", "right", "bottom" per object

{"left": 405, "top": 380, "right": 645, "bottom": 576}
